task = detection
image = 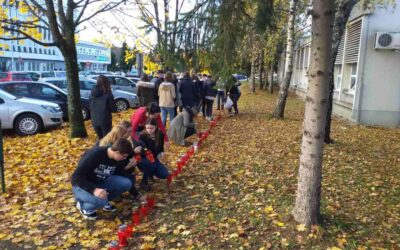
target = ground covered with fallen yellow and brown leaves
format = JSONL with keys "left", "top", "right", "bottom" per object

{"left": 0, "top": 86, "right": 400, "bottom": 249}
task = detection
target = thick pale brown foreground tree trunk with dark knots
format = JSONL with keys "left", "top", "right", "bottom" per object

{"left": 292, "top": 0, "right": 334, "bottom": 226}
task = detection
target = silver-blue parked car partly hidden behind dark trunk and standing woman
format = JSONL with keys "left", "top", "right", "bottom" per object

{"left": 41, "top": 77, "right": 139, "bottom": 111}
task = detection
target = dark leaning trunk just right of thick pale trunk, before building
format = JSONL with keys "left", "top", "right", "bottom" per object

{"left": 324, "top": 0, "right": 358, "bottom": 144}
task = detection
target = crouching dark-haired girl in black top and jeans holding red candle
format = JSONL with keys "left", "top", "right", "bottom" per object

{"left": 138, "top": 118, "right": 169, "bottom": 191}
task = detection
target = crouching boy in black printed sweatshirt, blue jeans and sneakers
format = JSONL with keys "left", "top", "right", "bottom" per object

{"left": 71, "top": 138, "right": 133, "bottom": 220}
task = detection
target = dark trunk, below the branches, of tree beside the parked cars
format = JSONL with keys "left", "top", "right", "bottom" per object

{"left": 61, "top": 33, "right": 87, "bottom": 138}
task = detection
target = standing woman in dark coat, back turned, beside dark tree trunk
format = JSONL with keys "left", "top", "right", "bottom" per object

{"left": 89, "top": 75, "right": 117, "bottom": 140}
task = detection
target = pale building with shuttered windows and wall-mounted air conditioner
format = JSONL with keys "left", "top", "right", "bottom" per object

{"left": 291, "top": 0, "right": 400, "bottom": 127}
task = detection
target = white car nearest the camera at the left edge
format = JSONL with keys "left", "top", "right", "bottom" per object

{"left": 0, "top": 90, "right": 63, "bottom": 135}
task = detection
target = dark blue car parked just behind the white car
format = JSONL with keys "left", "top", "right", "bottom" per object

{"left": 0, "top": 82, "right": 90, "bottom": 120}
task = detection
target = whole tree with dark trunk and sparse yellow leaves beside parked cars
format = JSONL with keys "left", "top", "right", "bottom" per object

{"left": 0, "top": 0, "right": 127, "bottom": 137}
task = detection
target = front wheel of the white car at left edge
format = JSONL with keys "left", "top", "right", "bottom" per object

{"left": 14, "top": 114, "right": 43, "bottom": 135}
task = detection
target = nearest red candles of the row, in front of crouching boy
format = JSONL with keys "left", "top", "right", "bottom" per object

{"left": 108, "top": 197, "right": 156, "bottom": 250}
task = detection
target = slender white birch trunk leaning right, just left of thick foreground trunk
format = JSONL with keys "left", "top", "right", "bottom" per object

{"left": 273, "top": 0, "right": 298, "bottom": 119}
